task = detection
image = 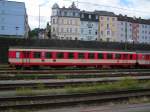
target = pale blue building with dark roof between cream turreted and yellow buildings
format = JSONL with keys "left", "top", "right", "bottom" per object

{"left": 80, "top": 11, "right": 99, "bottom": 41}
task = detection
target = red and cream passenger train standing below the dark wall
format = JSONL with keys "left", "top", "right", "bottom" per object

{"left": 8, "top": 47, "right": 150, "bottom": 68}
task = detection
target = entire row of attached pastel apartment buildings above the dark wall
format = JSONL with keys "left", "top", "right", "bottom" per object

{"left": 51, "top": 3, "right": 150, "bottom": 43}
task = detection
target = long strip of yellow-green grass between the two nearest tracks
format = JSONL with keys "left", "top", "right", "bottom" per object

{"left": 16, "top": 77, "right": 146, "bottom": 95}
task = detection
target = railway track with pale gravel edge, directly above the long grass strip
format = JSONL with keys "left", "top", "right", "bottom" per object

{"left": 0, "top": 76, "right": 150, "bottom": 91}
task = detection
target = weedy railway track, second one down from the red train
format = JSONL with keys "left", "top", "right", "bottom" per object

{"left": 0, "top": 70, "right": 150, "bottom": 81}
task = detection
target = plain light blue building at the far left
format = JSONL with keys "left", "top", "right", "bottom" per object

{"left": 0, "top": 0, "right": 29, "bottom": 38}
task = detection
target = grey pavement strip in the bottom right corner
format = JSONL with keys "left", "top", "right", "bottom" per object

{"left": 36, "top": 103, "right": 150, "bottom": 112}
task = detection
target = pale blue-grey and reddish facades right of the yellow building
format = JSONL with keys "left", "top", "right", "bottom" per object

{"left": 117, "top": 15, "right": 150, "bottom": 43}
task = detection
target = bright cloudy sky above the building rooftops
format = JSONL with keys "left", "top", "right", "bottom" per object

{"left": 8, "top": 0, "right": 150, "bottom": 29}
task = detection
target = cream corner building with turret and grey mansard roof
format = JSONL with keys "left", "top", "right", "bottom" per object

{"left": 51, "top": 3, "right": 80, "bottom": 40}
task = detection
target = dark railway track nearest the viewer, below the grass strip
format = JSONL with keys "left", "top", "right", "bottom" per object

{"left": 0, "top": 89, "right": 150, "bottom": 111}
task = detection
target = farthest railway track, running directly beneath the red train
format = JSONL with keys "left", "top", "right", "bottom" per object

{"left": 0, "top": 69, "right": 150, "bottom": 74}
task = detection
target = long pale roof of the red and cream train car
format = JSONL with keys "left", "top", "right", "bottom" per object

{"left": 9, "top": 46, "right": 135, "bottom": 53}
